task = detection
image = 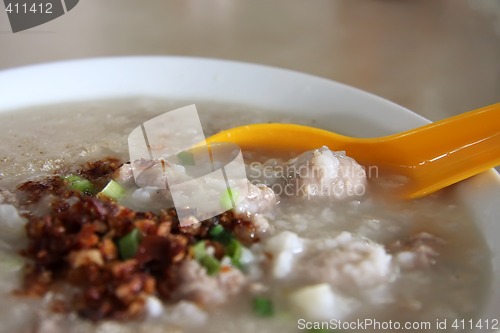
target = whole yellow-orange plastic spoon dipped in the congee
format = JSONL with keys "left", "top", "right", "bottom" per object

{"left": 207, "top": 103, "right": 500, "bottom": 198}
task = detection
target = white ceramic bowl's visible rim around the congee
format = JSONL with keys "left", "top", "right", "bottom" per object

{"left": 0, "top": 57, "right": 500, "bottom": 326}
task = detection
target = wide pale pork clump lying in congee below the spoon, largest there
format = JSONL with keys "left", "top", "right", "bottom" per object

{"left": 265, "top": 231, "right": 392, "bottom": 289}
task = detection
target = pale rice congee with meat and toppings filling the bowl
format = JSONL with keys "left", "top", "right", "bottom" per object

{"left": 0, "top": 99, "right": 492, "bottom": 333}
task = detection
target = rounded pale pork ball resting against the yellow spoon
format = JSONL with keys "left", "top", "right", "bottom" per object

{"left": 285, "top": 146, "right": 366, "bottom": 199}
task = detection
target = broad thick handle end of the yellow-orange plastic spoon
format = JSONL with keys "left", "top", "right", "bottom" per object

{"left": 381, "top": 103, "right": 500, "bottom": 197}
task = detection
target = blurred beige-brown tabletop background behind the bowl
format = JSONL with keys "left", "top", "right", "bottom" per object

{"left": 0, "top": 0, "right": 500, "bottom": 120}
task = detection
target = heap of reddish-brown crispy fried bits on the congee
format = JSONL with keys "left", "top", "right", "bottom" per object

{"left": 15, "top": 160, "right": 258, "bottom": 320}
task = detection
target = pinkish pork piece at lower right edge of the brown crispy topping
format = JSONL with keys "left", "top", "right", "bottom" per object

{"left": 174, "top": 260, "right": 247, "bottom": 306}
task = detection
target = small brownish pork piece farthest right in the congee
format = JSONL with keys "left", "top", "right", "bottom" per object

{"left": 391, "top": 232, "right": 444, "bottom": 270}
